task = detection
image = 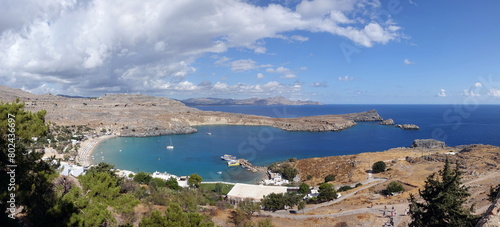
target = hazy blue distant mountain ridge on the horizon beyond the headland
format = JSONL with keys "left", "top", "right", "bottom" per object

{"left": 179, "top": 96, "right": 321, "bottom": 106}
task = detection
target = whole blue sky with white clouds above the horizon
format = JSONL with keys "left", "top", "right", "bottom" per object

{"left": 0, "top": 0, "right": 500, "bottom": 104}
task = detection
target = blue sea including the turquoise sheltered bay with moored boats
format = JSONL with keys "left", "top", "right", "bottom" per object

{"left": 93, "top": 105, "right": 500, "bottom": 183}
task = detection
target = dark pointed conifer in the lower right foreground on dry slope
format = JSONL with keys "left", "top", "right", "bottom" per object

{"left": 410, "top": 159, "right": 478, "bottom": 227}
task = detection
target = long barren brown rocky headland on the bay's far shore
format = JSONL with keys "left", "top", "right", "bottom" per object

{"left": 0, "top": 86, "right": 382, "bottom": 136}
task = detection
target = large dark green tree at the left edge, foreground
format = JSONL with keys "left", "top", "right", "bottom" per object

{"left": 0, "top": 100, "right": 74, "bottom": 226}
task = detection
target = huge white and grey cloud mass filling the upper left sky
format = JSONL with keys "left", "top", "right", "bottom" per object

{"left": 0, "top": 0, "right": 401, "bottom": 95}
